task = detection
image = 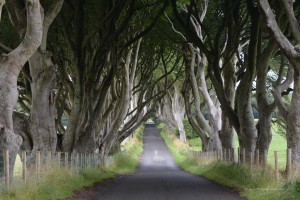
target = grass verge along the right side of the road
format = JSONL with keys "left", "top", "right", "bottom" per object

{"left": 161, "top": 129, "right": 300, "bottom": 200}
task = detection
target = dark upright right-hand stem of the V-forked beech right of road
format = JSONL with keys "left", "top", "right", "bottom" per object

{"left": 237, "top": 1, "right": 259, "bottom": 162}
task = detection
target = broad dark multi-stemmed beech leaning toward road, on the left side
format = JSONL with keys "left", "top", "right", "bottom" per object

{"left": 63, "top": 0, "right": 167, "bottom": 154}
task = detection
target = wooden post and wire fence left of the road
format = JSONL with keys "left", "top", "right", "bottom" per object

{"left": 0, "top": 150, "right": 113, "bottom": 190}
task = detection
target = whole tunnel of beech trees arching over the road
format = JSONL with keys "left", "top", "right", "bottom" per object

{"left": 0, "top": 0, "right": 300, "bottom": 178}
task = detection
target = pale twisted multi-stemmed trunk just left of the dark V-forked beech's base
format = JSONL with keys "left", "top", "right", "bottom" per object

{"left": 185, "top": 44, "right": 222, "bottom": 151}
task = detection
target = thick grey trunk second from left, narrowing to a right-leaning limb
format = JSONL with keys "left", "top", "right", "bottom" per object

{"left": 29, "top": 0, "right": 64, "bottom": 155}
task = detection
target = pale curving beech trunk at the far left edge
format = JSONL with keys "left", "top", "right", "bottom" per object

{"left": 0, "top": 0, "right": 42, "bottom": 178}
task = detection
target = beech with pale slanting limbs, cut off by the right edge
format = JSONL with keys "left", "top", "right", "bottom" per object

{"left": 259, "top": 0, "right": 300, "bottom": 168}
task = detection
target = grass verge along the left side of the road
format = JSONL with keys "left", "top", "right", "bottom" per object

{"left": 0, "top": 127, "right": 143, "bottom": 200}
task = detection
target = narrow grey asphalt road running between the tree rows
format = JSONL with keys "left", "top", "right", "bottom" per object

{"left": 96, "top": 125, "right": 243, "bottom": 200}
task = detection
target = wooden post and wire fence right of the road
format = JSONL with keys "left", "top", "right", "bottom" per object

{"left": 189, "top": 148, "right": 293, "bottom": 178}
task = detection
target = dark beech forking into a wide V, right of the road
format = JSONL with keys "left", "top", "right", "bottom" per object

{"left": 172, "top": 0, "right": 268, "bottom": 160}
